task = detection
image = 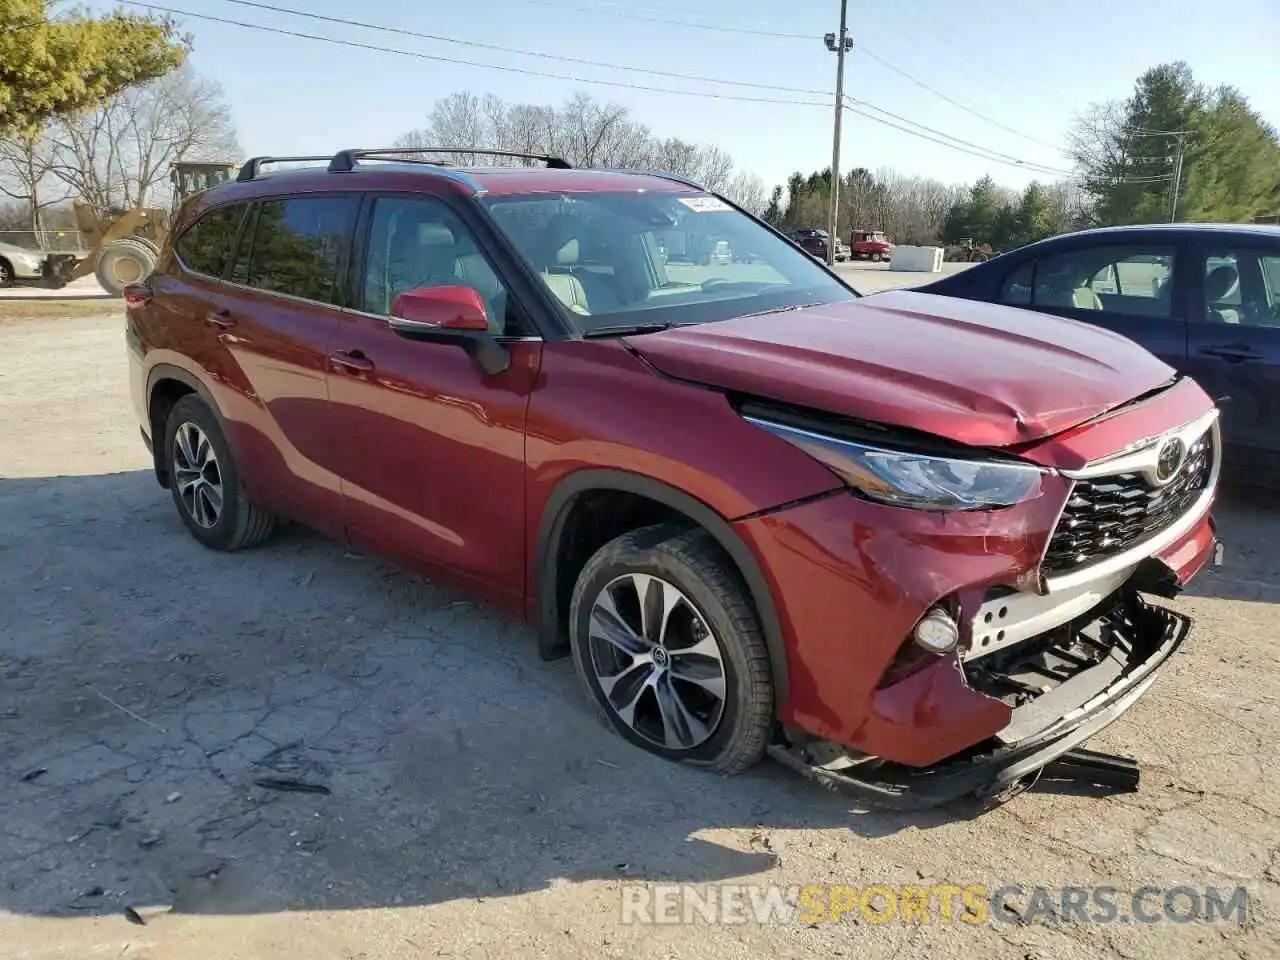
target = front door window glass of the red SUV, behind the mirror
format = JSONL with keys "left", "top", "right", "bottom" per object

{"left": 360, "top": 197, "right": 521, "bottom": 335}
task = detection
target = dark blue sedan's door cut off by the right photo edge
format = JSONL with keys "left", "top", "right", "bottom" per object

{"left": 1188, "top": 239, "right": 1280, "bottom": 474}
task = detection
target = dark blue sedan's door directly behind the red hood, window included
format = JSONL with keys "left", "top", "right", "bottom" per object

{"left": 997, "top": 239, "right": 1189, "bottom": 370}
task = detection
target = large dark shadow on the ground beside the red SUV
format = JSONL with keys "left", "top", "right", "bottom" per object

{"left": 0, "top": 471, "right": 978, "bottom": 915}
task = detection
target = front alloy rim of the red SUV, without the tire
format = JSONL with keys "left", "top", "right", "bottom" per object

{"left": 588, "top": 573, "right": 727, "bottom": 750}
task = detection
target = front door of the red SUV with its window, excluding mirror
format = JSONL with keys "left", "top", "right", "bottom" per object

{"left": 329, "top": 196, "right": 541, "bottom": 600}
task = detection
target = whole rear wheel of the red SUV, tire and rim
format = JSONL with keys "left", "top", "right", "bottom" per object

{"left": 164, "top": 394, "right": 275, "bottom": 550}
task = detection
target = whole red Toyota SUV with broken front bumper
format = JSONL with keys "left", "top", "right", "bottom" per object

{"left": 127, "top": 150, "right": 1220, "bottom": 805}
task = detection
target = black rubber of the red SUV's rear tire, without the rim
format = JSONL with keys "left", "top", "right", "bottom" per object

{"left": 163, "top": 394, "right": 276, "bottom": 550}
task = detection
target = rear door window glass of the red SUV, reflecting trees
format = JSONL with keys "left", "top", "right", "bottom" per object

{"left": 244, "top": 195, "right": 360, "bottom": 303}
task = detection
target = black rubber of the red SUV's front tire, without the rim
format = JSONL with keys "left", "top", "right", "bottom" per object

{"left": 570, "top": 525, "right": 776, "bottom": 774}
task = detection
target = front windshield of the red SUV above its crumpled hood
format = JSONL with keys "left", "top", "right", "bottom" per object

{"left": 485, "top": 192, "right": 858, "bottom": 333}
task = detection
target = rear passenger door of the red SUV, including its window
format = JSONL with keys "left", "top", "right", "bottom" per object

{"left": 210, "top": 193, "right": 360, "bottom": 534}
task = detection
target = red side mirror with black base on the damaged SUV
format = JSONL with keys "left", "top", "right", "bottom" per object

{"left": 387, "top": 284, "right": 511, "bottom": 376}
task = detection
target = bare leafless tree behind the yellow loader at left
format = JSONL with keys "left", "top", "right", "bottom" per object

{"left": 51, "top": 68, "right": 241, "bottom": 212}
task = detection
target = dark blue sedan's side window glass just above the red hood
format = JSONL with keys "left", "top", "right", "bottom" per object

{"left": 1032, "top": 246, "right": 1174, "bottom": 319}
